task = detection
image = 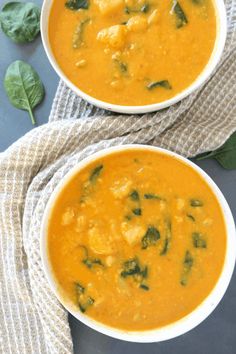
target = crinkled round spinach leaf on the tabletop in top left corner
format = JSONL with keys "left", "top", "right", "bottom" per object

{"left": 0, "top": 2, "right": 40, "bottom": 43}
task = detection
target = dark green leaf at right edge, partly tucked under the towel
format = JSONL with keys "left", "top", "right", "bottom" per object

{"left": 197, "top": 132, "right": 236, "bottom": 170}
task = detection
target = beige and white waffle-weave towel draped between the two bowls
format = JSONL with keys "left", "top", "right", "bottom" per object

{"left": 0, "top": 0, "right": 236, "bottom": 354}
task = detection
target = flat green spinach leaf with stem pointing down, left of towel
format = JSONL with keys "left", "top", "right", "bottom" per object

{"left": 4, "top": 60, "right": 44, "bottom": 124}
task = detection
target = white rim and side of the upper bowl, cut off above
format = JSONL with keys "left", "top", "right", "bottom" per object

{"left": 41, "top": 0, "right": 227, "bottom": 114}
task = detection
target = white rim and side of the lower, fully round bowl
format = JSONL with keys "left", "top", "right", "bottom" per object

{"left": 40, "top": 145, "right": 236, "bottom": 343}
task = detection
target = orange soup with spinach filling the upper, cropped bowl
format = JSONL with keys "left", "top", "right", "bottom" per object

{"left": 49, "top": 0, "right": 216, "bottom": 106}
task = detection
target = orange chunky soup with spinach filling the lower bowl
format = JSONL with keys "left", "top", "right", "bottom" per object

{"left": 48, "top": 150, "right": 226, "bottom": 330}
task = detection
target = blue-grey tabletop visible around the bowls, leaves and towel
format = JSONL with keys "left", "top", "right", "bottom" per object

{"left": 0, "top": 0, "right": 236, "bottom": 354}
